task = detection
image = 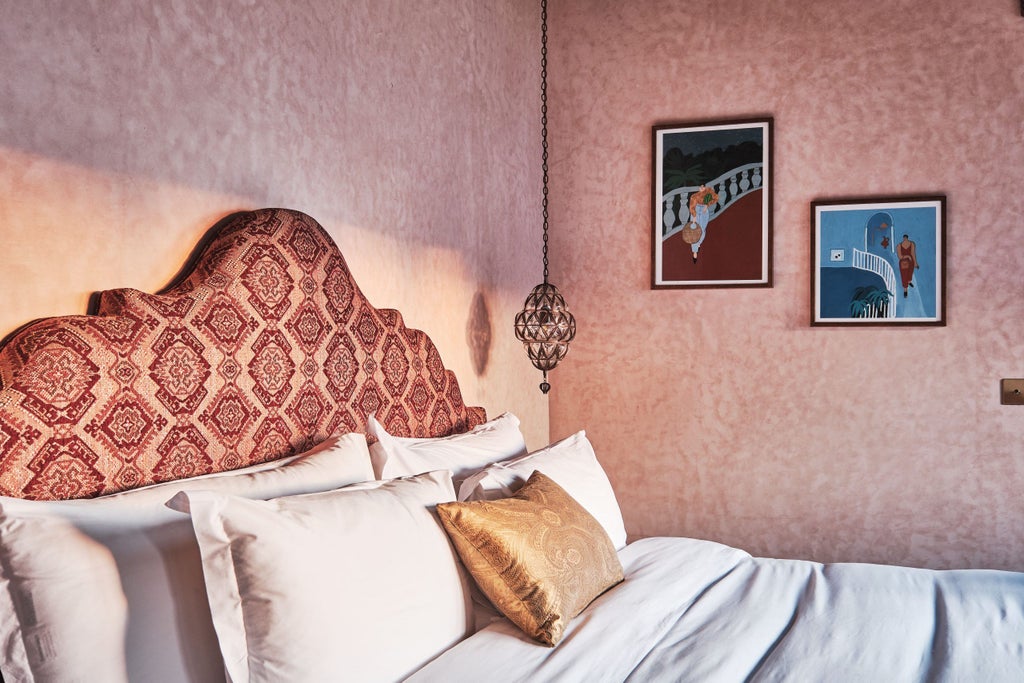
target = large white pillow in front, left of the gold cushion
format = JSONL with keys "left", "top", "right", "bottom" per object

{"left": 174, "top": 471, "right": 473, "bottom": 683}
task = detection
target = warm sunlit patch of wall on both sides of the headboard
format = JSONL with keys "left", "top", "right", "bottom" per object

{"left": 0, "top": 148, "right": 548, "bottom": 446}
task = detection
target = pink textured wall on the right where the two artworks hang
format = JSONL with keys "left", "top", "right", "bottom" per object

{"left": 551, "top": 0, "right": 1024, "bottom": 570}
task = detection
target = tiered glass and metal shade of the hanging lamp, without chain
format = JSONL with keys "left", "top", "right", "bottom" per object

{"left": 515, "top": 283, "right": 575, "bottom": 388}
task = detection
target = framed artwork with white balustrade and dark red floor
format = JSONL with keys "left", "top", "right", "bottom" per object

{"left": 651, "top": 118, "right": 772, "bottom": 289}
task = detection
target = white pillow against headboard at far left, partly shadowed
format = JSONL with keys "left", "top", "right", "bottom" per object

{"left": 0, "top": 434, "right": 373, "bottom": 683}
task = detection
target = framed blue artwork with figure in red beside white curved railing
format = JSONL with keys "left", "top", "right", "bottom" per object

{"left": 811, "top": 196, "right": 946, "bottom": 326}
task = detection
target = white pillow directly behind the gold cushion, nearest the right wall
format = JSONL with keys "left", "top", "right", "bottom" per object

{"left": 459, "top": 431, "right": 626, "bottom": 550}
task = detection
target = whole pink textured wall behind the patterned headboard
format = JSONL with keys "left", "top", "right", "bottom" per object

{"left": 0, "top": 0, "right": 548, "bottom": 445}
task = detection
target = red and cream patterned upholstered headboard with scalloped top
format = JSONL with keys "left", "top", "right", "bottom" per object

{"left": 0, "top": 209, "right": 484, "bottom": 499}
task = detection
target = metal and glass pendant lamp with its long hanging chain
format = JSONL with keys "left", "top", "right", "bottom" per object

{"left": 515, "top": 0, "right": 575, "bottom": 393}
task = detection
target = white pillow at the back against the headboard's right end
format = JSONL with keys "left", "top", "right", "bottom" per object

{"left": 367, "top": 413, "right": 526, "bottom": 485}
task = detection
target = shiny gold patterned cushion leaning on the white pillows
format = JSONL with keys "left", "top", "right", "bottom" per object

{"left": 437, "top": 472, "right": 623, "bottom": 646}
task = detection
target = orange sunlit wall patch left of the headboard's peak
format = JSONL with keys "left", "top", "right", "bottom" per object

{"left": 0, "top": 148, "right": 242, "bottom": 334}
